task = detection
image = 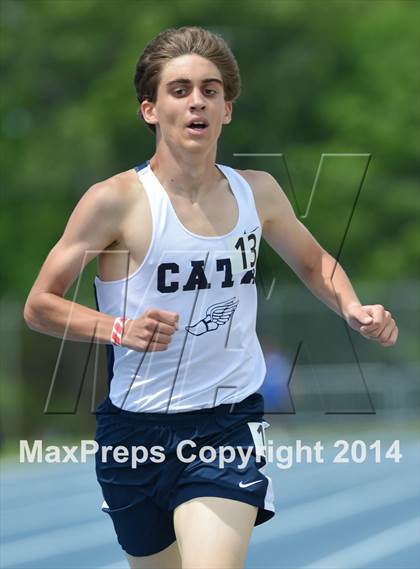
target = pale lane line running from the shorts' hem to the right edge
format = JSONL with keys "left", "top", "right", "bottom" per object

{"left": 252, "top": 468, "right": 418, "bottom": 544}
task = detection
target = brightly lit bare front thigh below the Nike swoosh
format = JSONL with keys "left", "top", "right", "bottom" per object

{"left": 174, "top": 497, "right": 258, "bottom": 569}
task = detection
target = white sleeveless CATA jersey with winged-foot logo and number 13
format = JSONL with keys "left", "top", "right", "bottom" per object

{"left": 95, "top": 162, "right": 266, "bottom": 413}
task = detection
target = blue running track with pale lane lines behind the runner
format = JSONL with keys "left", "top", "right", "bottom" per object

{"left": 1, "top": 417, "right": 420, "bottom": 569}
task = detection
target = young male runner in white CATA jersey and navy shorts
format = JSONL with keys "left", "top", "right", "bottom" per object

{"left": 25, "top": 27, "right": 398, "bottom": 569}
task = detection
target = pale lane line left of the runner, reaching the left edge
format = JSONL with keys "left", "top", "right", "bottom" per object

{"left": 1, "top": 519, "right": 111, "bottom": 569}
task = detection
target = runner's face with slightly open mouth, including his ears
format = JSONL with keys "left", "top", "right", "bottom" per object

{"left": 142, "top": 54, "right": 232, "bottom": 150}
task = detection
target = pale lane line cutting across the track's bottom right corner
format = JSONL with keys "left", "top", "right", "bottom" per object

{"left": 303, "top": 518, "right": 420, "bottom": 569}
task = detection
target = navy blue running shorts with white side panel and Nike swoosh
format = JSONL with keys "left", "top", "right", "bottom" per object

{"left": 96, "top": 393, "right": 274, "bottom": 557}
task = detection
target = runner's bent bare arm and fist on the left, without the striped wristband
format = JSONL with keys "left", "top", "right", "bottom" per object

{"left": 24, "top": 179, "right": 177, "bottom": 351}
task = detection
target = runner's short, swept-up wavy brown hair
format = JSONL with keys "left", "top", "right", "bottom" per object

{"left": 134, "top": 26, "right": 241, "bottom": 131}
